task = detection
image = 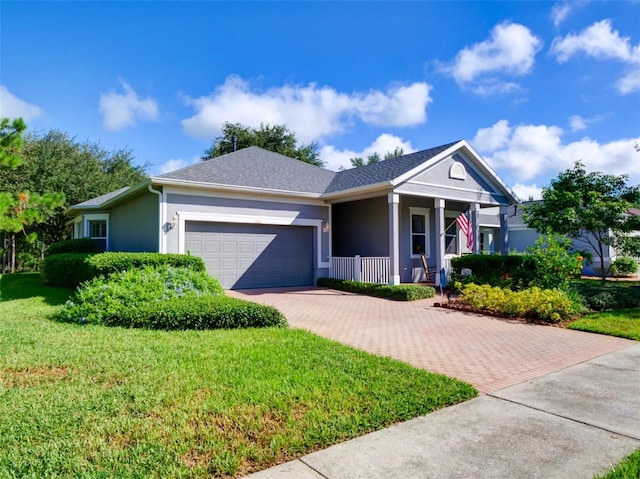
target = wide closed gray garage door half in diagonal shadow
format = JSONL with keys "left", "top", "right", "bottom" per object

{"left": 185, "top": 221, "right": 314, "bottom": 289}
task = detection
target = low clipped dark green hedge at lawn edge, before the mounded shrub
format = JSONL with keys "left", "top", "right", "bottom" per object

{"left": 103, "top": 295, "right": 287, "bottom": 330}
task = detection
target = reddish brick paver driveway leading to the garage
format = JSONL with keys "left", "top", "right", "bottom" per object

{"left": 229, "top": 288, "right": 636, "bottom": 393}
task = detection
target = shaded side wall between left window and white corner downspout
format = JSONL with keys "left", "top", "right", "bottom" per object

{"left": 109, "top": 193, "right": 159, "bottom": 251}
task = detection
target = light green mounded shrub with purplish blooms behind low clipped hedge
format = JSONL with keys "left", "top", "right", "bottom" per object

{"left": 57, "top": 266, "right": 224, "bottom": 324}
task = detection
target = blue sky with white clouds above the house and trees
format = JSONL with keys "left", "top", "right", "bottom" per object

{"left": 0, "top": 0, "right": 640, "bottom": 199}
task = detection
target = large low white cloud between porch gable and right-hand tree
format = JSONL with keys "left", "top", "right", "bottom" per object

{"left": 472, "top": 120, "right": 640, "bottom": 183}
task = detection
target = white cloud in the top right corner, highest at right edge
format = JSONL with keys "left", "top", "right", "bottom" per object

{"left": 551, "top": 20, "right": 640, "bottom": 94}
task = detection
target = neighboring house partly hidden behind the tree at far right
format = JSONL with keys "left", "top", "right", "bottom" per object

{"left": 500, "top": 201, "right": 640, "bottom": 276}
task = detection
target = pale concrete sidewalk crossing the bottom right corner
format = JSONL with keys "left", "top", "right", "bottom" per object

{"left": 250, "top": 344, "right": 640, "bottom": 479}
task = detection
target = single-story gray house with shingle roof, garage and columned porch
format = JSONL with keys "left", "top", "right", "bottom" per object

{"left": 69, "top": 140, "right": 517, "bottom": 289}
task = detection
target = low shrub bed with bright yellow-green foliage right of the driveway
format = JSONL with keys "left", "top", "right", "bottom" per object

{"left": 458, "top": 284, "right": 584, "bottom": 323}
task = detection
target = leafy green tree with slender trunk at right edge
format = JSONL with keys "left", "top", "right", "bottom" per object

{"left": 524, "top": 161, "right": 640, "bottom": 280}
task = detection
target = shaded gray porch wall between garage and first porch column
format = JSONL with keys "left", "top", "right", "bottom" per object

{"left": 331, "top": 195, "right": 389, "bottom": 256}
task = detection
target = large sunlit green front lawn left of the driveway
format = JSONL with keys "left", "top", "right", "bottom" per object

{"left": 0, "top": 274, "right": 477, "bottom": 478}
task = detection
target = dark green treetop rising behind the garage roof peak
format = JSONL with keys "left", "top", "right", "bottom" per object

{"left": 204, "top": 122, "right": 324, "bottom": 166}
